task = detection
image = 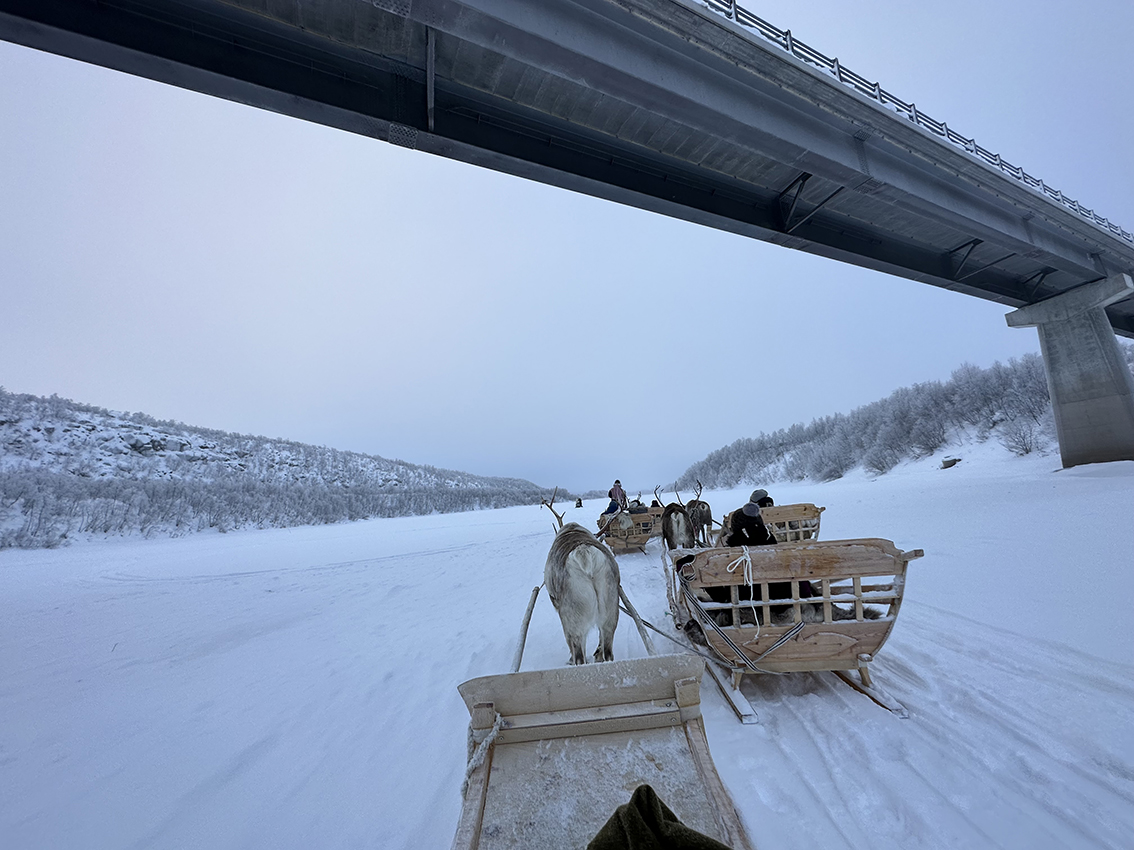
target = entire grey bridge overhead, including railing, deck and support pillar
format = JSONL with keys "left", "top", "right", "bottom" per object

{"left": 0, "top": 0, "right": 1134, "bottom": 466}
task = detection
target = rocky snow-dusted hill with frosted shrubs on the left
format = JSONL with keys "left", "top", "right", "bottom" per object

{"left": 0, "top": 389, "right": 562, "bottom": 549}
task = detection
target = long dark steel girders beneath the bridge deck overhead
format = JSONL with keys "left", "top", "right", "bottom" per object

{"left": 0, "top": 0, "right": 1134, "bottom": 335}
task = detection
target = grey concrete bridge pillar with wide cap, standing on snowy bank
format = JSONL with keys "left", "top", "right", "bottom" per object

{"left": 1005, "top": 274, "right": 1134, "bottom": 467}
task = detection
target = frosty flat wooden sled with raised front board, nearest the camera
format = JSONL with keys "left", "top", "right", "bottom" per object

{"left": 452, "top": 655, "right": 752, "bottom": 850}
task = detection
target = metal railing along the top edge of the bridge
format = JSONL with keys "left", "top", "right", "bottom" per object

{"left": 702, "top": 0, "right": 1134, "bottom": 244}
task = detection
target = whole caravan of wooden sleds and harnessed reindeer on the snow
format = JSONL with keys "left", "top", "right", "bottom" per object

{"left": 452, "top": 484, "right": 923, "bottom": 850}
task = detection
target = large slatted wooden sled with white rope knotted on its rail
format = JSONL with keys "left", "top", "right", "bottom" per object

{"left": 667, "top": 537, "right": 923, "bottom": 720}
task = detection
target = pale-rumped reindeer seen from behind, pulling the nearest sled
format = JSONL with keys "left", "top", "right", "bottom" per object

{"left": 540, "top": 487, "right": 620, "bottom": 664}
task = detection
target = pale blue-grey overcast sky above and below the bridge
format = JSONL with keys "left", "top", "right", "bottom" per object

{"left": 0, "top": 0, "right": 1134, "bottom": 491}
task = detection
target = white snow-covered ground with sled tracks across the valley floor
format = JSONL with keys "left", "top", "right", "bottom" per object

{"left": 0, "top": 445, "right": 1134, "bottom": 850}
